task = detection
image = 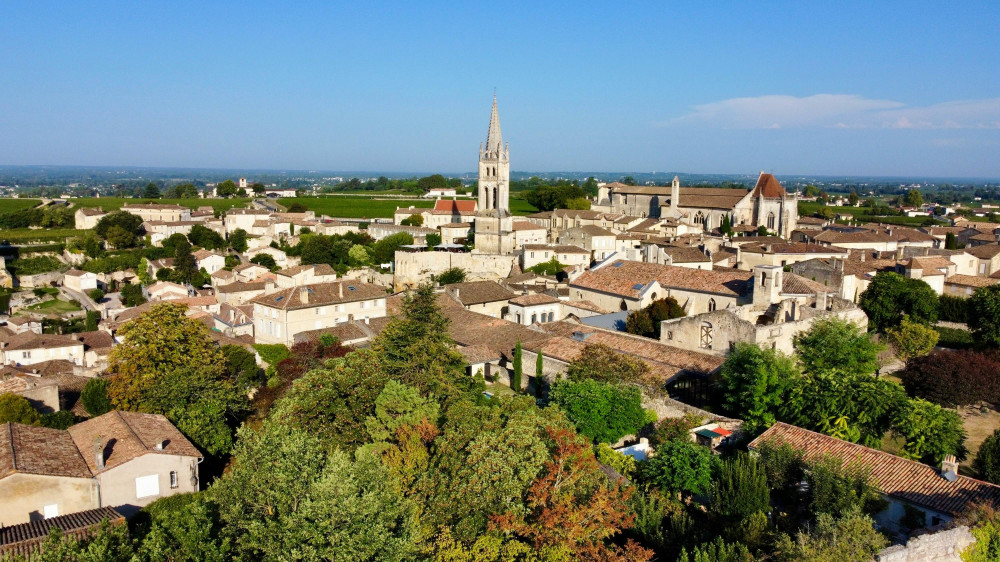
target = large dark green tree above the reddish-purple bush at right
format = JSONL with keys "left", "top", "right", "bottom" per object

{"left": 858, "top": 271, "right": 938, "bottom": 332}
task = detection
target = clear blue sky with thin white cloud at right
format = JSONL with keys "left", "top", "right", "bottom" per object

{"left": 0, "top": 0, "right": 1000, "bottom": 177}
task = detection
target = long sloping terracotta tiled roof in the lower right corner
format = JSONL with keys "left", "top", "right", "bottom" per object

{"left": 750, "top": 422, "right": 1000, "bottom": 515}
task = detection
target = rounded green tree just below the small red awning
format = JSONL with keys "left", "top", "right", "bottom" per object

{"left": 639, "top": 440, "right": 719, "bottom": 494}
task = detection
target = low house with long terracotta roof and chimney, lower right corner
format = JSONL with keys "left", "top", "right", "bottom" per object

{"left": 749, "top": 422, "right": 1000, "bottom": 532}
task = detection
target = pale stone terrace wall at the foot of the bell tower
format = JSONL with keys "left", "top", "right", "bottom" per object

{"left": 394, "top": 252, "right": 517, "bottom": 291}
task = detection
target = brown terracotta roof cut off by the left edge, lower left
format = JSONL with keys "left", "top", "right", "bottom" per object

{"left": 0, "top": 422, "right": 92, "bottom": 478}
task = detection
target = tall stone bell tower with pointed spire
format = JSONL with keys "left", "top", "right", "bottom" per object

{"left": 474, "top": 94, "right": 514, "bottom": 254}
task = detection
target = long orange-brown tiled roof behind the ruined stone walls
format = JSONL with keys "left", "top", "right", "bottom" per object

{"left": 570, "top": 260, "right": 753, "bottom": 298}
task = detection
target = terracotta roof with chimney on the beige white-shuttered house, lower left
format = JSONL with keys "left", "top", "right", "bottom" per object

{"left": 67, "top": 410, "right": 202, "bottom": 474}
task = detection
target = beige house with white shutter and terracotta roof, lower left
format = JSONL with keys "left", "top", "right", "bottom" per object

{"left": 66, "top": 410, "right": 202, "bottom": 516}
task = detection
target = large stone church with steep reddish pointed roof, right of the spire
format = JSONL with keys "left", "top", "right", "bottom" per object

{"left": 591, "top": 172, "right": 799, "bottom": 238}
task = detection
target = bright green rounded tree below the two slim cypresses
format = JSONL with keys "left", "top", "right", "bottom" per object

{"left": 549, "top": 379, "right": 651, "bottom": 443}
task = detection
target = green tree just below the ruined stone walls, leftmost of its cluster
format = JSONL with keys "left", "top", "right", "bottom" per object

{"left": 720, "top": 343, "right": 799, "bottom": 433}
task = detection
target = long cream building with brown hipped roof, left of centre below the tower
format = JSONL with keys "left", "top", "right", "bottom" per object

{"left": 250, "top": 280, "right": 386, "bottom": 345}
